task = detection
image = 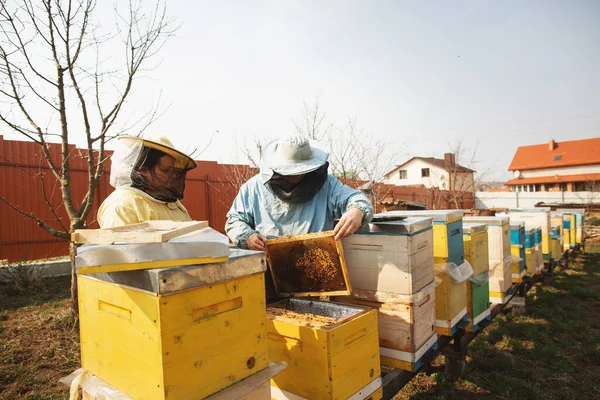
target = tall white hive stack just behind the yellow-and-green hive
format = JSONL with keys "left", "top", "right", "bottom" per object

{"left": 465, "top": 216, "right": 512, "bottom": 304}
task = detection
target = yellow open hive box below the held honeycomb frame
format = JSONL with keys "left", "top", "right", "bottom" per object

{"left": 267, "top": 304, "right": 381, "bottom": 399}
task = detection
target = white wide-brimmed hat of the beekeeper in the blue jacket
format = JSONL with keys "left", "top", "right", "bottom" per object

{"left": 262, "top": 134, "right": 329, "bottom": 175}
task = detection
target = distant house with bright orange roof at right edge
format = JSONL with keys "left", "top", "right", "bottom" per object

{"left": 506, "top": 138, "right": 600, "bottom": 192}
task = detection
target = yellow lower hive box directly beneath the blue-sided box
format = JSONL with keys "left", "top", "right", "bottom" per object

{"left": 435, "top": 273, "right": 467, "bottom": 336}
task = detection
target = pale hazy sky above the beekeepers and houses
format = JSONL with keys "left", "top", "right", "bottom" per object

{"left": 5, "top": 0, "right": 600, "bottom": 180}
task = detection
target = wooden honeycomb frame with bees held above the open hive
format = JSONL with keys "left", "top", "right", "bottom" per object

{"left": 267, "top": 231, "right": 351, "bottom": 297}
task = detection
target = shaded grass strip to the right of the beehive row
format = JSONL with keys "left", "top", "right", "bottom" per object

{"left": 395, "top": 244, "right": 600, "bottom": 400}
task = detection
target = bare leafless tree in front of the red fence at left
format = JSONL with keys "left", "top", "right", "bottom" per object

{"left": 0, "top": 0, "right": 176, "bottom": 312}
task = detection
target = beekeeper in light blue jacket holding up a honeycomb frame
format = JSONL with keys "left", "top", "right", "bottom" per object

{"left": 225, "top": 134, "right": 373, "bottom": 250}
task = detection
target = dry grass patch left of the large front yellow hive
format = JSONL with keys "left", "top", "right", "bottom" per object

{"left": 0, "top": 277, "right": 79, "bottom": 400}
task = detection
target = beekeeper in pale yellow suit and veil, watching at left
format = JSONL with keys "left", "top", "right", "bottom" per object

{"left": 98, "top": 135, "right": 198, "bottom": 228}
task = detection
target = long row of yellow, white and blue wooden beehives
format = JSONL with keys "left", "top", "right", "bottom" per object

{"left": 68, "top": 211, "right": 584, "bottom": 399}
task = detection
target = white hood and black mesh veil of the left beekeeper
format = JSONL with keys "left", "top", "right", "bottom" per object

{"left": 110, "top": 135, "right": 198, "bottom": 202}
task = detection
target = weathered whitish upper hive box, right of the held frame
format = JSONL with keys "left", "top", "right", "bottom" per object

{"left": 342, "top": 218, "right": 434, "bottom": 295}
